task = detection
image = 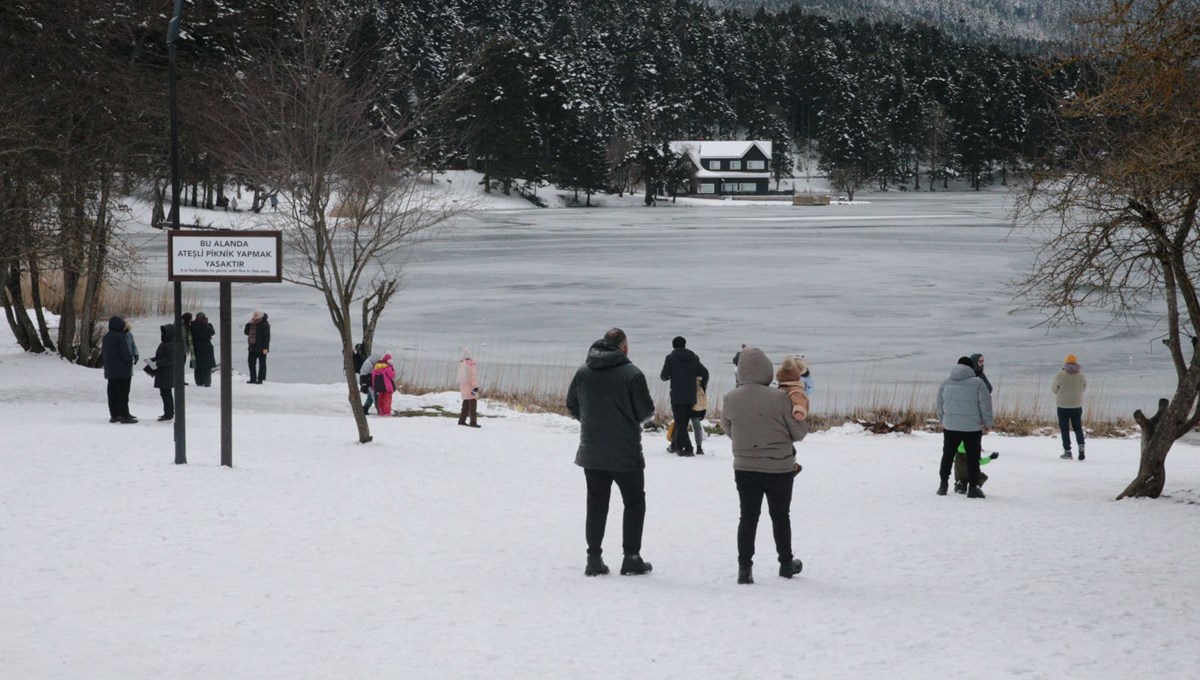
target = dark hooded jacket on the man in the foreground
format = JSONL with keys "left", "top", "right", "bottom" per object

{"left": 566, "top": 339, "right": 654, "bottom": 473}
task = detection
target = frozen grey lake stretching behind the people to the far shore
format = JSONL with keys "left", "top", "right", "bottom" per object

{"left": 136, "top": 192, "right": 1174, "bottom": 415}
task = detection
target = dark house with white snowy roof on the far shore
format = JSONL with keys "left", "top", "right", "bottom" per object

{"left": 671, "top": 140, "right": 770, "bottom": 195}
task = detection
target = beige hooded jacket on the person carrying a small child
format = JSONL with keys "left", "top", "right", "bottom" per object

{"left": 721, "top": 347, "right": 809, "bottom": 474}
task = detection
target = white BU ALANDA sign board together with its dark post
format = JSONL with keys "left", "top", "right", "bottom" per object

{"left": 167, "top": 230, "right": 283, "bottom": 468}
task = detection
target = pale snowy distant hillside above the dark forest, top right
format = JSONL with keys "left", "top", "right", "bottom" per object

{"left": 706, "top": 0, "right": 1104, "bottom": 42}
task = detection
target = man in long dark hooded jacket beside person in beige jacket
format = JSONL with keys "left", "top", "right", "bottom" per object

{"left": 566, "top": 329, "right": 654, "bottom": 576}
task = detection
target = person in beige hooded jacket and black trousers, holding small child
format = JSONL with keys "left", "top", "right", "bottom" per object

{"left": 721, "top": 347, "right": 809, "bottom": 584}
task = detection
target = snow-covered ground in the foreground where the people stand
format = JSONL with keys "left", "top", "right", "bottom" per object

{"left": 0, "top": 350, "right": 1200, "bottom": 680}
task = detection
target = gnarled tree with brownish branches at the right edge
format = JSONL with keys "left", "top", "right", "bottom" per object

{"left": 1018, "top": 0, "right": 1200, "bottom": 498}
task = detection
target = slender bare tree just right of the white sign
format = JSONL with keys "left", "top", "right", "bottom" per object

{"left": 217, "top": 6, "right": 469, "bottom": 443}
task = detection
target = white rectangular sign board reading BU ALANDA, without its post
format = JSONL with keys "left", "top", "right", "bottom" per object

{"left": 167, "top": 230, "right": 282, "bottom": 282}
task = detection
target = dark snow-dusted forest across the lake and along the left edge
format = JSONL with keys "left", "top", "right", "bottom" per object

{"left": 0, "top": 0, "right": 1075, "bottom": 362}
